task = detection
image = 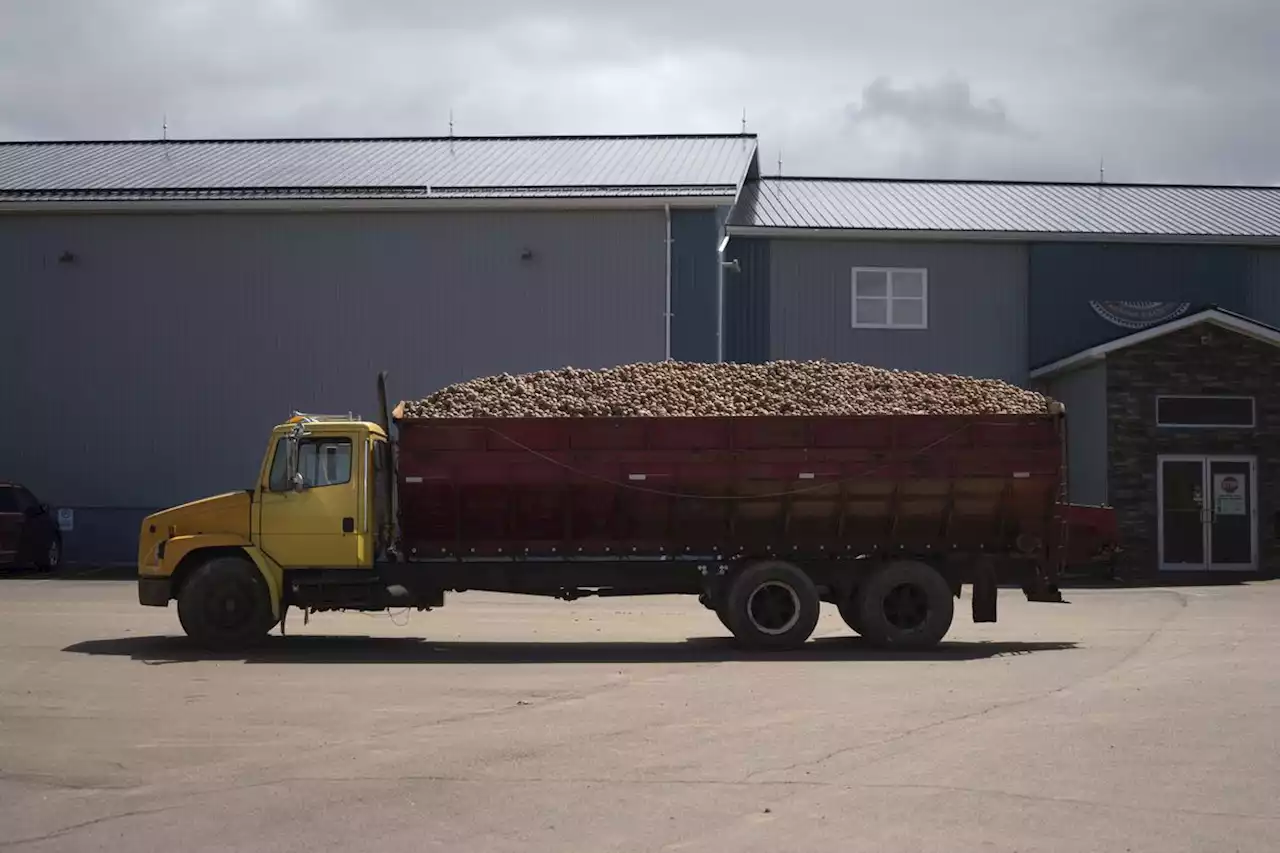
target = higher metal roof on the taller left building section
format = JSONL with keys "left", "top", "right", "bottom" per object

{"left": 0, "top": 134, "right": 755, "bottom": 196}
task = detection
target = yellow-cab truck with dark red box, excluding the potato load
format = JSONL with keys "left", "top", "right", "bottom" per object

{"left": 138, "top": 374, "right": 1096, "bottom": 649}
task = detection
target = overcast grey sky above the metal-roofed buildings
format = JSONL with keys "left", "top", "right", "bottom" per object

{"left": 0, "top": 0, "right": 1280, "bottom": 183}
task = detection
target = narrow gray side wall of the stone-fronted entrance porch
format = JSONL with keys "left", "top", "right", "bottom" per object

{"left": 1044, "top": 361, "right": 1107, "bottom": 506}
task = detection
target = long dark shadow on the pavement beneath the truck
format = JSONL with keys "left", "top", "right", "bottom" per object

{"left": 63, "top": 635, "right": 1076, "bottom": 665}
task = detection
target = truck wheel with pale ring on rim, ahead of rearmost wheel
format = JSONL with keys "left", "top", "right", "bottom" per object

{"left": 721, "top": 560, "right": 822, "bottom": 649}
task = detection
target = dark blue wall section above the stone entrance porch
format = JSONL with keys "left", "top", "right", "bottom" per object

{"left": 1030, "top": 242, "right": 1249, "bottom": 368}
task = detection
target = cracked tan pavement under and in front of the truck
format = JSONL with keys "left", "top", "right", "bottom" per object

{"left": 0, "top": 578, "right": 1280, "bottom": 853}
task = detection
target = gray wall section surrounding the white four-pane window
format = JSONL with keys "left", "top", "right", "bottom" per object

{"left": 771, "top": 240, "right": 1027, "bottom": 384}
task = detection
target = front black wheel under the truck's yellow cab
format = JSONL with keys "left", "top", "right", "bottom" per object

{"left": 178, "top": 557, "right": 276, "bottom": 652}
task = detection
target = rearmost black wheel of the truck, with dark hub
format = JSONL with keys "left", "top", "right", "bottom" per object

{"left": 855, "top": 561, "right": 955, "bottom": 649}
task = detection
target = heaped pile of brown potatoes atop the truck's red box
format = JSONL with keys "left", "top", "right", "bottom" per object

{"left": 403, "top": 361, "right": 1052, "bottom": 418}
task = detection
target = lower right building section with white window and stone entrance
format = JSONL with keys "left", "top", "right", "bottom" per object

{"left": 724, "top": 178, "right": 1280, "bottom": 571}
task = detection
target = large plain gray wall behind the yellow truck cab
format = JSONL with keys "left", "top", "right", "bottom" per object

{"left": 0, "top": 211, "right": 670, "bottom": 558}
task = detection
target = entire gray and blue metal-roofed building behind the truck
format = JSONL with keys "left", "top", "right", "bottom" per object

{"left": 0, "top": 136, "right": 1280, "bottom": 571}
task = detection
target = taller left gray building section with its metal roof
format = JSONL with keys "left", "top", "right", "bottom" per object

{"left": 0, "top": 136, "right": 756, "bottom": 561}
